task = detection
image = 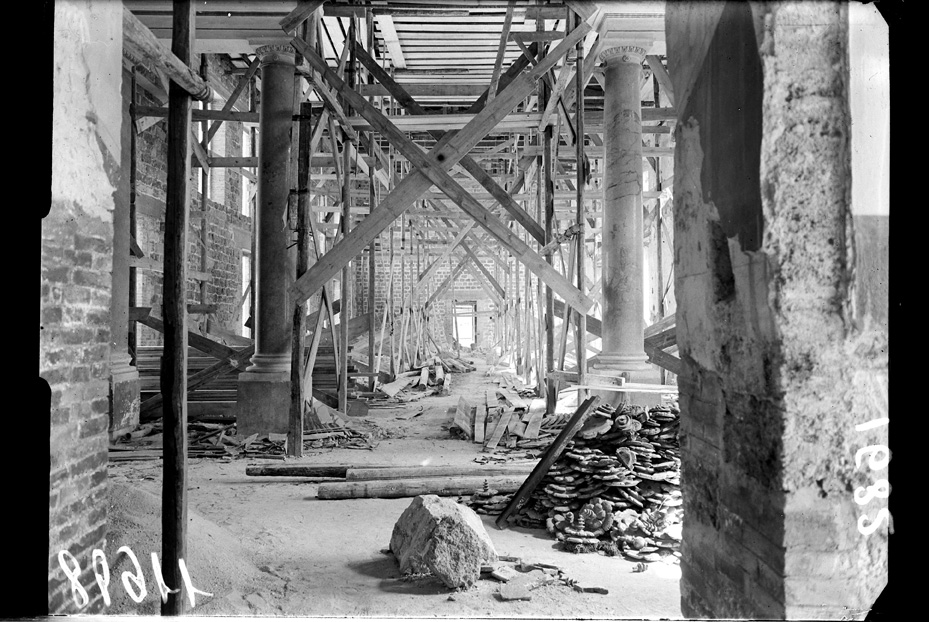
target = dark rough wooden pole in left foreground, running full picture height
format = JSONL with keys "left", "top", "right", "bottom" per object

{"left": 161, "top": 0, "right": 196, "bottom": 615}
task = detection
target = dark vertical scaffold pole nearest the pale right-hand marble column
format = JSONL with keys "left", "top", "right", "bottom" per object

{"left": 568, "top": 10, "right": 589, "bottom": 400}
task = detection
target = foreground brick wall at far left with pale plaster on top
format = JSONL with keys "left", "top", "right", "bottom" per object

{"left": 46, "top": 1, "right": 122, "bottom": 614}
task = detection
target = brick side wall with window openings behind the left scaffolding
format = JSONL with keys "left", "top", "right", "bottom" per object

{"left": 130, "top": 54, "right": 252, "bottom": 346}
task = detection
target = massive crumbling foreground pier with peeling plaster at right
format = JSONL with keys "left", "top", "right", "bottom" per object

{"left": 666, "top": 2, "right": 888, "bottom": 619}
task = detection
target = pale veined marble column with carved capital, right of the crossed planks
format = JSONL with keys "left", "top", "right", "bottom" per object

{"left": 590, "top": 45, "right": 652, "bottom": 404}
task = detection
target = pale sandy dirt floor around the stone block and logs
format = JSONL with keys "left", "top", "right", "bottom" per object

{"left": 106, "top": 356, "right": 681, "bottom": 619}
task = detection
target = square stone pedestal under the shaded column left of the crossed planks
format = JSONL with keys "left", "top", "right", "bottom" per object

{"left": 235, "top": 371, "right": 290, "bottom": 438}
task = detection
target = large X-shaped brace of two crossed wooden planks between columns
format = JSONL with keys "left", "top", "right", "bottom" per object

{"left": 292, "top": 24, "right": 593, "bottom": 311}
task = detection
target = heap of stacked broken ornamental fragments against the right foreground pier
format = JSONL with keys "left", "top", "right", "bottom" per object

{"left": 470, "top": 405, "right": 682, "bottom": 561}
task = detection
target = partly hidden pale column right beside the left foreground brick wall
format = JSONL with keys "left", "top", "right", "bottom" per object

{"left": 109, "top": 69, "right": 139, "bottom": 436}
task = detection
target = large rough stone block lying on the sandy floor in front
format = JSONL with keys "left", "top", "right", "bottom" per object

{"left": 390, "top": 495, "right": 497, "bottom": 588}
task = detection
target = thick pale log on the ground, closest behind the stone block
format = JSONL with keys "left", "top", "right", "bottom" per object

{"left": 316, "top": 475, "right": 523, "bottom": 499}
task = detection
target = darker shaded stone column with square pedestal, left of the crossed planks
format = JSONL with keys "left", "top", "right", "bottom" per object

{"left": 236, "top": 45, "right": 295, "bottom": 436}
